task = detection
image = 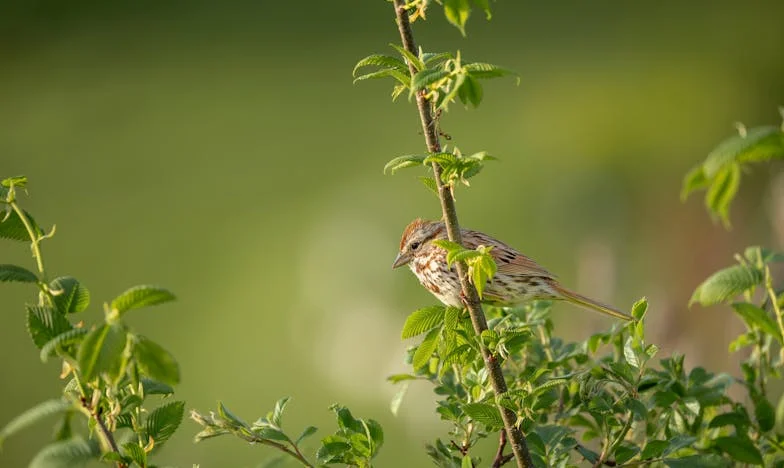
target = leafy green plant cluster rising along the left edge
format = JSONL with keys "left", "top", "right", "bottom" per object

{"left": 0, "top": 177, "right": 185, "bottom": 467}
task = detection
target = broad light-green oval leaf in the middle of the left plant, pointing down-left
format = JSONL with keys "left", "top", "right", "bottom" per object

{"left": 76, "top": 324, "right": 128, "bottom": 381}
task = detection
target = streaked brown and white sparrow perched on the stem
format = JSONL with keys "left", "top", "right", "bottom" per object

{"left": 392, "top": 219, "right": 631, "bottom": 320}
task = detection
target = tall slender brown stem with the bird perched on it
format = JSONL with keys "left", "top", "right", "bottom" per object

{"left": 393, "top": 0, "right": 533, "bottom": 468}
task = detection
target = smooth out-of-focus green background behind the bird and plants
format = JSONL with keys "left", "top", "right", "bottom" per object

{"left": 0, "top": 0, "right": 784, "bottom": 467}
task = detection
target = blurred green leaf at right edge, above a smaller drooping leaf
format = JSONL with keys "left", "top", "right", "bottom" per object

{"left": 703, "top": 126, "right": 784, "bottom": 178}
